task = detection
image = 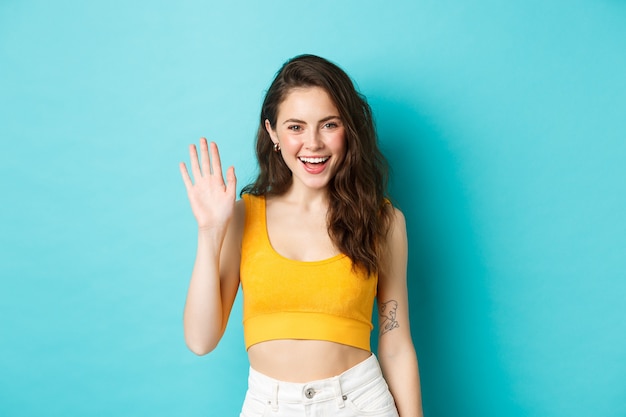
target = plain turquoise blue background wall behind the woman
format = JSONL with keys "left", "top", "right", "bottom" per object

{"left": 0, "top": 0, "right": 626, "bottom": 417}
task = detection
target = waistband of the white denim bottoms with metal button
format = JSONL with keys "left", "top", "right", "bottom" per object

{"left": 248, "top": 354, "right": 382, "bottom": 404}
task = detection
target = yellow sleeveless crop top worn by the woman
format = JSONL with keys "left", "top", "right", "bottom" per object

{"left": 240, "top": 194, "right": 378, "bottom": 351}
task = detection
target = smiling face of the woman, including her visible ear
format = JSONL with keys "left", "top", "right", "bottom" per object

{"left": 265, "top": 87, "right": 346, "bottom": 193}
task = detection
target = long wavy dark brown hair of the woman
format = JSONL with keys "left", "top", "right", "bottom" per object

{"left": 241, "top": 55, "right": 393, "bottom": 275}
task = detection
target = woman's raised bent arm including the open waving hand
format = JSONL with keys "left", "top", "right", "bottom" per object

{"left": 180, "top": 138, "right": 245, "bottom": 355}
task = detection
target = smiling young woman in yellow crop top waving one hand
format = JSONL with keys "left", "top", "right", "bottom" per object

{"left": 180, "top": 55, "right": 422, "bottom": 417}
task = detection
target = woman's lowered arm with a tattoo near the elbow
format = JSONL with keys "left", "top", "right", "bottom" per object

{"left": 378, "top": 209, "right": 423, "bottom": 417}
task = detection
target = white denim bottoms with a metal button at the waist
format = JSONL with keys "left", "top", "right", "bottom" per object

{"left": 240, "top": 355, "right": 398, "bottom": 417}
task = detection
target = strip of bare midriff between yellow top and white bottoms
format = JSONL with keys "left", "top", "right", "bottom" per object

{"left": 248, "top": 339, "right": 371, "bottom": 382}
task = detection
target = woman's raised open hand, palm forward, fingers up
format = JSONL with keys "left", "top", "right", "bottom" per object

{"left": 180, "top": 138, "right": 237, "bottom": 233}
